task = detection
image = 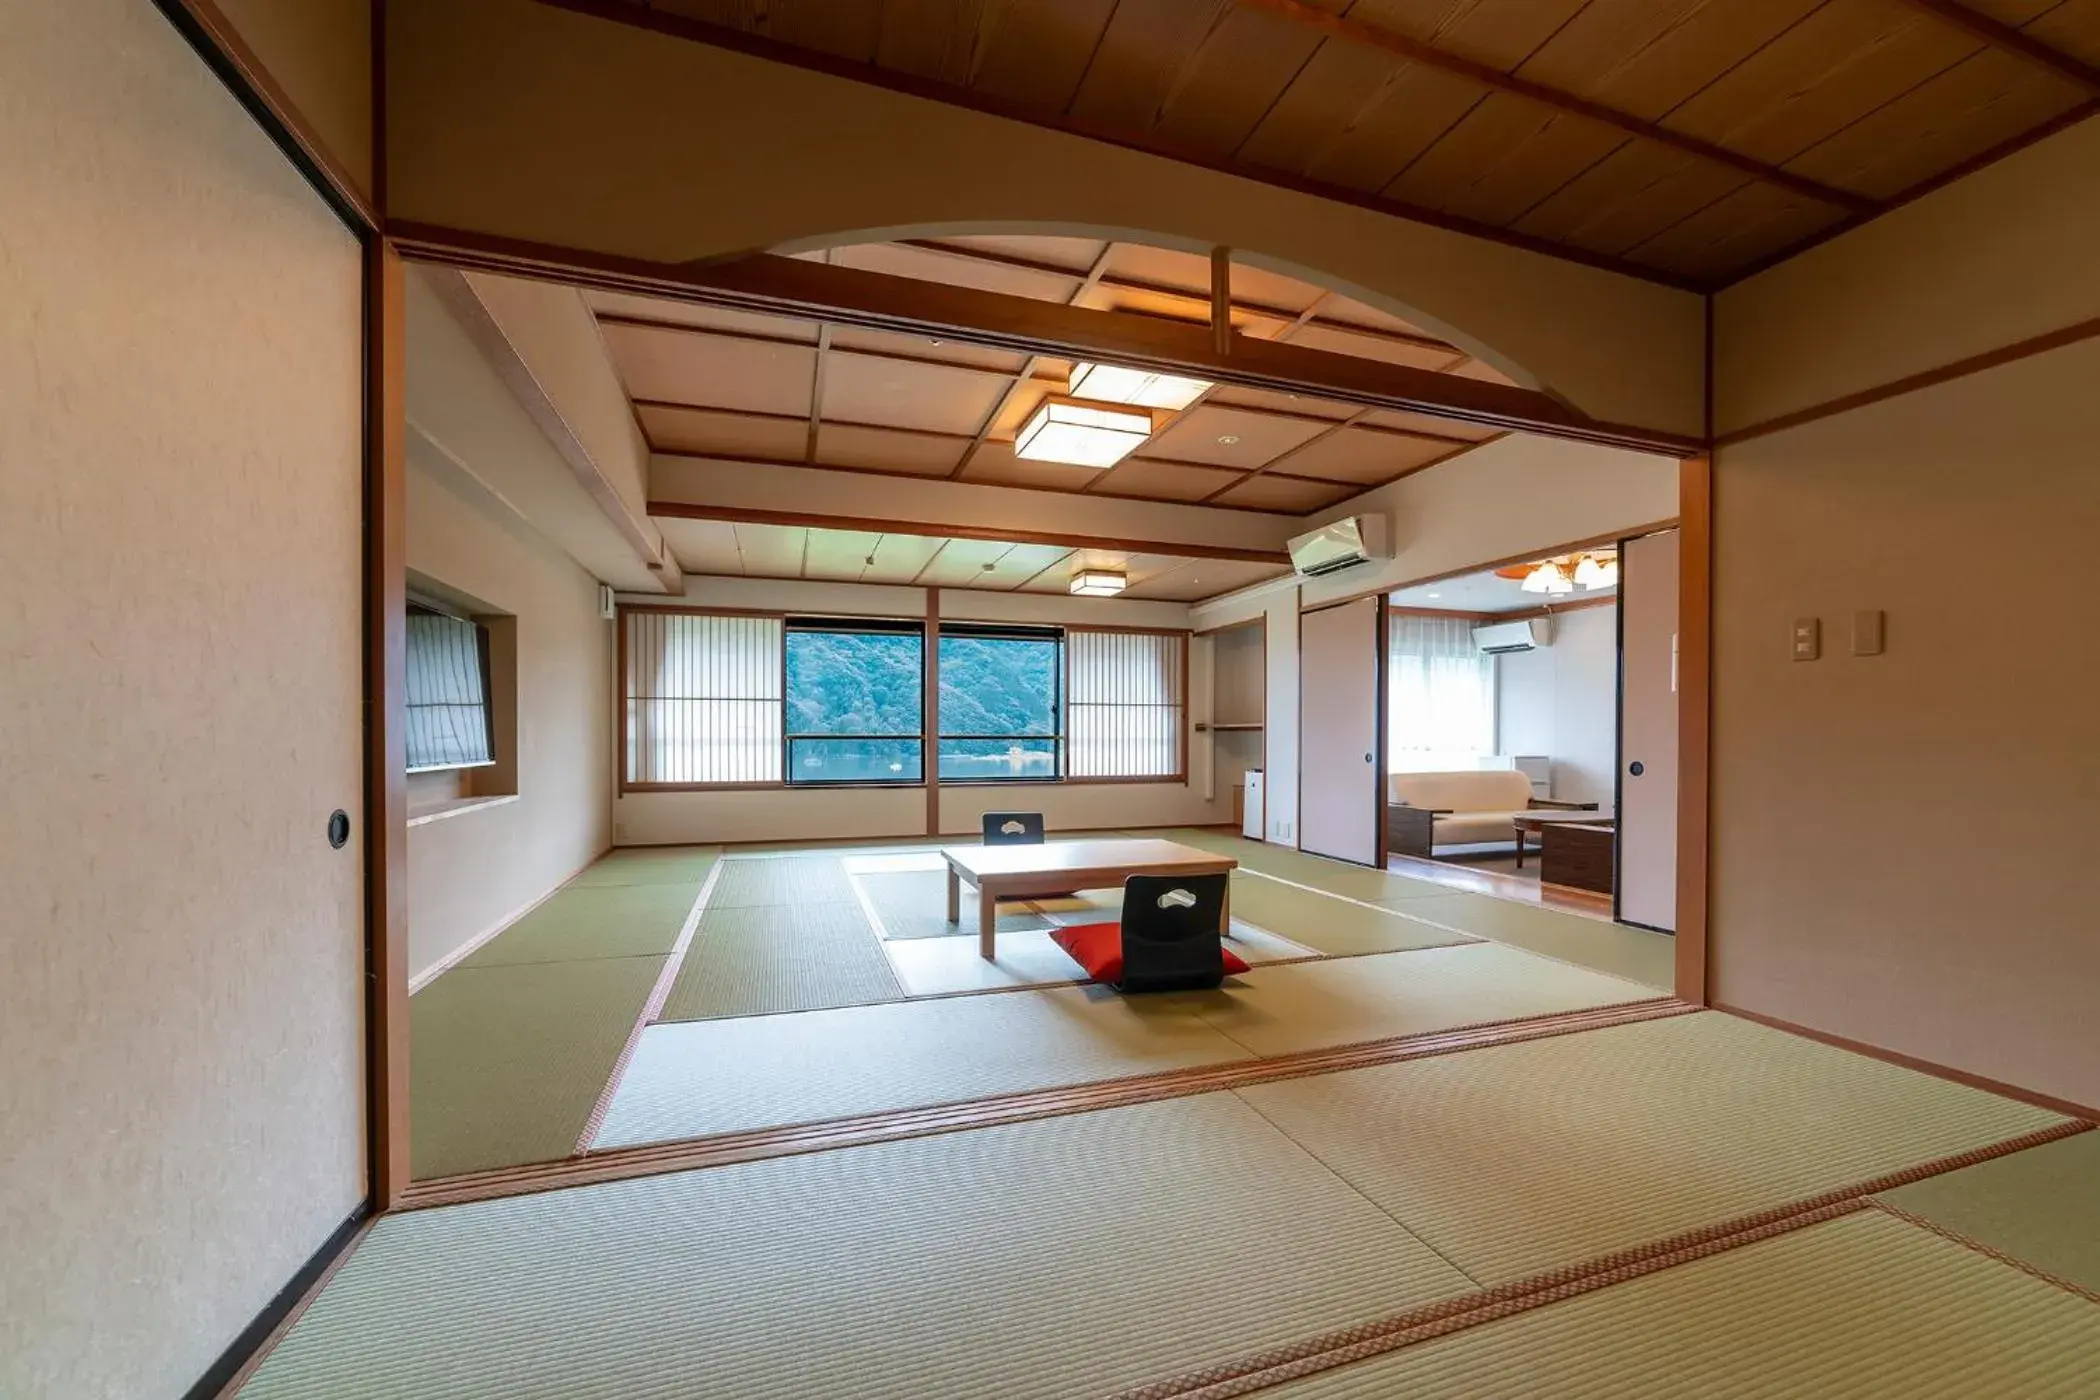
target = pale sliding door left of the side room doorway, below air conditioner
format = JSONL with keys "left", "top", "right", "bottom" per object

{"left": 1298, "top": 598, "right": 1386, "bottom": 865}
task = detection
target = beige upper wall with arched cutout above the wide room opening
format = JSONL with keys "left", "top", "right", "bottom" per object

{"left": 386, "top": 0, "right": 1705, "bottom": 432}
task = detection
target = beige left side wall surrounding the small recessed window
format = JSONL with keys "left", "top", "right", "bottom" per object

{"left": 407, "top": 453, "right": 613, "bottom": 980}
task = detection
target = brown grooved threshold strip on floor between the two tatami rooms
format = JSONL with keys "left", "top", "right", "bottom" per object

{"left": 401, "top": 997, "right": 1701, "bottom": 1211}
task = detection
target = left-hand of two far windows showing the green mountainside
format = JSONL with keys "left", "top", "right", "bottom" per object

{"left": 788, "top": 619, "right": 926, "bottom": 783}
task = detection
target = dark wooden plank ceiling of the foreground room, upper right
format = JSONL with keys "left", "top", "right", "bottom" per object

{"left": 583, "top": 0, "right": 2100, "bottom": 285}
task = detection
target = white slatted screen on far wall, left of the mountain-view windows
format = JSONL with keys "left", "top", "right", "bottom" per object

{"left": 626, "top": 613, "right": 781, "bottom": 783}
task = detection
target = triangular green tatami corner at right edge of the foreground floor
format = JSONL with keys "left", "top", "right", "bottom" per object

{"left": 1882, "top": 1131, "right": 2100, "bottom": 1293}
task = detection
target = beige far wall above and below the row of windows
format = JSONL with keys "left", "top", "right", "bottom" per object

{"left": 613, "top": 575, "right": 1233, "bottom": 846}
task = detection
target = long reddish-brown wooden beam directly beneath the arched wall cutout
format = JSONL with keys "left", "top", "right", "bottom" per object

{"left": 391, "top": 222, "right": 1705, "bottom": 455}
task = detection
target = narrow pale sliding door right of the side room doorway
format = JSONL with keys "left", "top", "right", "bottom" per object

{"left": 1619, "top": 529, "right": 1678, "bottom": 930}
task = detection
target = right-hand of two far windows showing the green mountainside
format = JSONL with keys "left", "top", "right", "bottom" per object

{"left": 941, "top": 625, "right": 1065, "bottom": 783}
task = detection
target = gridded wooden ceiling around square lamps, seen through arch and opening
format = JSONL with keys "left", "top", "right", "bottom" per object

{"left": 586, "top": 235, "right": 1508, "bottom": 520}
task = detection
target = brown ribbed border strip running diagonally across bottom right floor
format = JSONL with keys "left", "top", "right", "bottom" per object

{"left": 1109, "top": 1119, "right": 2096, "bottom": 1400}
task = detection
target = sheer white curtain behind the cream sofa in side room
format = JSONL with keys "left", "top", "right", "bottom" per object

{"left": 1386, "top": 613, "right": 1495, "bottom": 772}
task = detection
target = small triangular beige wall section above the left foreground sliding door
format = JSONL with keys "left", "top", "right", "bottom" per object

{"left": 216, "top": 0, "right": 372, "bottom": 195}
